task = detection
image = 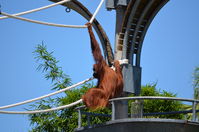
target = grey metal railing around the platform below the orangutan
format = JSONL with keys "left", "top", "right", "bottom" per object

{"left": 77, "top": 96, "right": 199, "bottom": 128}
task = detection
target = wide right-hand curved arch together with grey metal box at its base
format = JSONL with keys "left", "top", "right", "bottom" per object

{"left": 116, "top": 0, "right": 168, "bottom": 95}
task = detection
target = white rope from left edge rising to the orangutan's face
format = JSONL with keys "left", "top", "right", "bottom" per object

{"left": 0, "top": 78, "right": 93, "bottom": 110}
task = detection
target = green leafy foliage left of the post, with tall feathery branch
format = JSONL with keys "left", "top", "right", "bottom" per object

{"left": 29, "top": 43, "right": 110, "bottom": 132}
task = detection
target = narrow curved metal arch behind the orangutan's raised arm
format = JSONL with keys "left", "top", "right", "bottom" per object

{"left": 49, "top": 0, "right": 114, "bottom": 65}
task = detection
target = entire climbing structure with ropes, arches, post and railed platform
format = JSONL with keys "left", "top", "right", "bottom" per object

{"left": 0, "top": 0, "right": 199, "bottom": 132}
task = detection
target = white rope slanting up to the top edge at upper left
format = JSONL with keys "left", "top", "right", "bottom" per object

{"left": 0, "top": 0, "right": 71, "bottom": 20}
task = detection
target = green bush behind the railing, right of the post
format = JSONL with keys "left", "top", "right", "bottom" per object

{"left": 141, "top": 84, "right": 184, "bottom": 119}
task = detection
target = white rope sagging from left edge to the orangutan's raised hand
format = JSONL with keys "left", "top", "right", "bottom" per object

{"left": 1, "top": 12, "right": 87, "bottom": 28}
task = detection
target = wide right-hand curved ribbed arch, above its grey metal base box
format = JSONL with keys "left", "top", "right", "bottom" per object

{"left": 120, "top": 0, "right": 169, "bottom": 66}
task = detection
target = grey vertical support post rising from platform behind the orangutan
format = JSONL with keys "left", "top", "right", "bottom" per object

{"left": 106, "top": 0, "right": 133, "bottom": 120}
